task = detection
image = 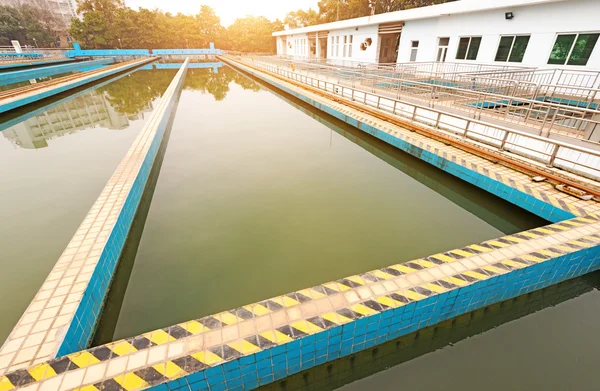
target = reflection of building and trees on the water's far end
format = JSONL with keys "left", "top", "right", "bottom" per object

{"left": 2, "top": 64, "right": 260, "bottom": 149}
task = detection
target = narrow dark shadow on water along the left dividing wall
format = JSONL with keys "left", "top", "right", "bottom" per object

{"left": 91, "top": 82, "right": 179, "bottom": 346}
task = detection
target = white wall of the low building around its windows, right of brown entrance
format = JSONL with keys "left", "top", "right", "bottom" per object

{"left": 398, "top": 0, "right": 600, "bottom": 69}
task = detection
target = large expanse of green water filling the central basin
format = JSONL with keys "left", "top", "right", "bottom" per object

{"left": 96, "top": 68, "right": 543, "bottom": 343}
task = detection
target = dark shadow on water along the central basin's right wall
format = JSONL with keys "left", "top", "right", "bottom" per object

{"left": 227, "top": 66, "right": 548, "bottom": 234}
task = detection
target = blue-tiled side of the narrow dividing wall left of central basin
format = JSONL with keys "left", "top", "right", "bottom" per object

{"left": 56, "top": 64, "right": 185, "bottom": 357}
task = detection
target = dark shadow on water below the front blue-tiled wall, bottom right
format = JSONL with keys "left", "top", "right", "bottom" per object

{"left": 258, "top": 272, "right": 600, "bottom": 391}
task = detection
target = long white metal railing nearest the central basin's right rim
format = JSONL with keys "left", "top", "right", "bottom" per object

{"left": 234, "top": 56, "right": 600, "bottom": 180}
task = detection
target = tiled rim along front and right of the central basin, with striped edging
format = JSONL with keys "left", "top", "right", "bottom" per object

{"left": 0, "top": 56, "right": 600, "bottom": 391}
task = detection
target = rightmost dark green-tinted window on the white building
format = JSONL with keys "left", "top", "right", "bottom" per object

{"left": 548, "top": 33, "right": 600, "bottom": 65}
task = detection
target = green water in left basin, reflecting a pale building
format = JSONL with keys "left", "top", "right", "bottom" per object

{"left": 0, "top": 71, "right": 176, "bottom": 342}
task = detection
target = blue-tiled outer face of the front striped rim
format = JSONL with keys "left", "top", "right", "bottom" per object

{"left": 149, "top": 242, "right": 600, "bottom": 391}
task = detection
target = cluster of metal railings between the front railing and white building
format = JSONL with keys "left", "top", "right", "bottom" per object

{"left": 255, "top": 57, "right": 600, "bottom": 140}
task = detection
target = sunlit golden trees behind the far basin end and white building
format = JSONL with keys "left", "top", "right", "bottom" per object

{"left": 68, "top": 0, "right": 453, "bottom": 52}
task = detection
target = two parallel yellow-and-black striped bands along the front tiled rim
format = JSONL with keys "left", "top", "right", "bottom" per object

{"left": 0, "top": 215, "right": 600, "bottom": 391}
